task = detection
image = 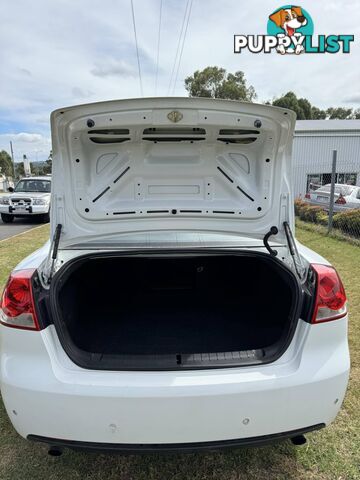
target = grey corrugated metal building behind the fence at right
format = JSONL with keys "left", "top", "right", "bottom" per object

{"left": 293, "top": 120, "right": 360, "bottom": 197}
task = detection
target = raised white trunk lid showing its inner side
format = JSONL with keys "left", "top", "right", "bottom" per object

{"left": 51, "top": 98, "right": 295, "bottom": 249}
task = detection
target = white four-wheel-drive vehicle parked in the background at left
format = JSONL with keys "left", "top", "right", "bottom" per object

{"left": 0, "top": 176, "right": 51, "bottom": 223}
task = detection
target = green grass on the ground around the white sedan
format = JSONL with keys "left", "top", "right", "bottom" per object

{"left": 0, "top": 227, "right": 360, "bottom": 480}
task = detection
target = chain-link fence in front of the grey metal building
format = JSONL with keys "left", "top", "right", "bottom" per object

{"left": 293, "top": 151, "right": 360, "bottom": 242}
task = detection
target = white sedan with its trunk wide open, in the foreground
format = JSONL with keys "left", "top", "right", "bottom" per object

{"left": 0, "top": 98, "right": 349, "bottom": 454}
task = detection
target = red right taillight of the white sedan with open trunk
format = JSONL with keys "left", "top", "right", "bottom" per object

{"left": 311, "top": 264, "right": 347, "bottom": 323}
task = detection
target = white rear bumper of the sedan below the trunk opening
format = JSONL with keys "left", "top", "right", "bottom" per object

{"left": 0, "top": 318, "right": 349, "bottom": 450}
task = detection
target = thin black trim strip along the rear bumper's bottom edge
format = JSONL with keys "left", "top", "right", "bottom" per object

{"left": 27, "top": 423, "right": 325, "bottom": 454}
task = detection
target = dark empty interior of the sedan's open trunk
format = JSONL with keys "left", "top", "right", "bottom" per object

{"left": 56, "top": 257, "right": 292, "bottom": 355}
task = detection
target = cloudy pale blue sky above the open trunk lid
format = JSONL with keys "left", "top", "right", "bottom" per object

{"left": 0, "top": 0, "right": 360, "bottom": 161}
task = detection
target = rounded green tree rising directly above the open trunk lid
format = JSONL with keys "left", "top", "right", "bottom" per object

{"left": 185, "top": 67, "right": 256, "bottom": 102}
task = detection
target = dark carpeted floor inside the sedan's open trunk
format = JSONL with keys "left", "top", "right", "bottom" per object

{"left": 73, "top": 292, "right": 283, "bottom": 354}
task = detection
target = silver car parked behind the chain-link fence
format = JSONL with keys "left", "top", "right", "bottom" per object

{"left": 305, "top": 183, "right": 360, "bottom": 212}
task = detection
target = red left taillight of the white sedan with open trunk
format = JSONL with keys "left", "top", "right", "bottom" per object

{"left": 0, "top": 269, "right": 40, "bottom": 330}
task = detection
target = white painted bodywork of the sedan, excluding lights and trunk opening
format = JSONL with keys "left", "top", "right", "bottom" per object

{"left": 0, "top": 98, "right": 350, "bottom": 448}
